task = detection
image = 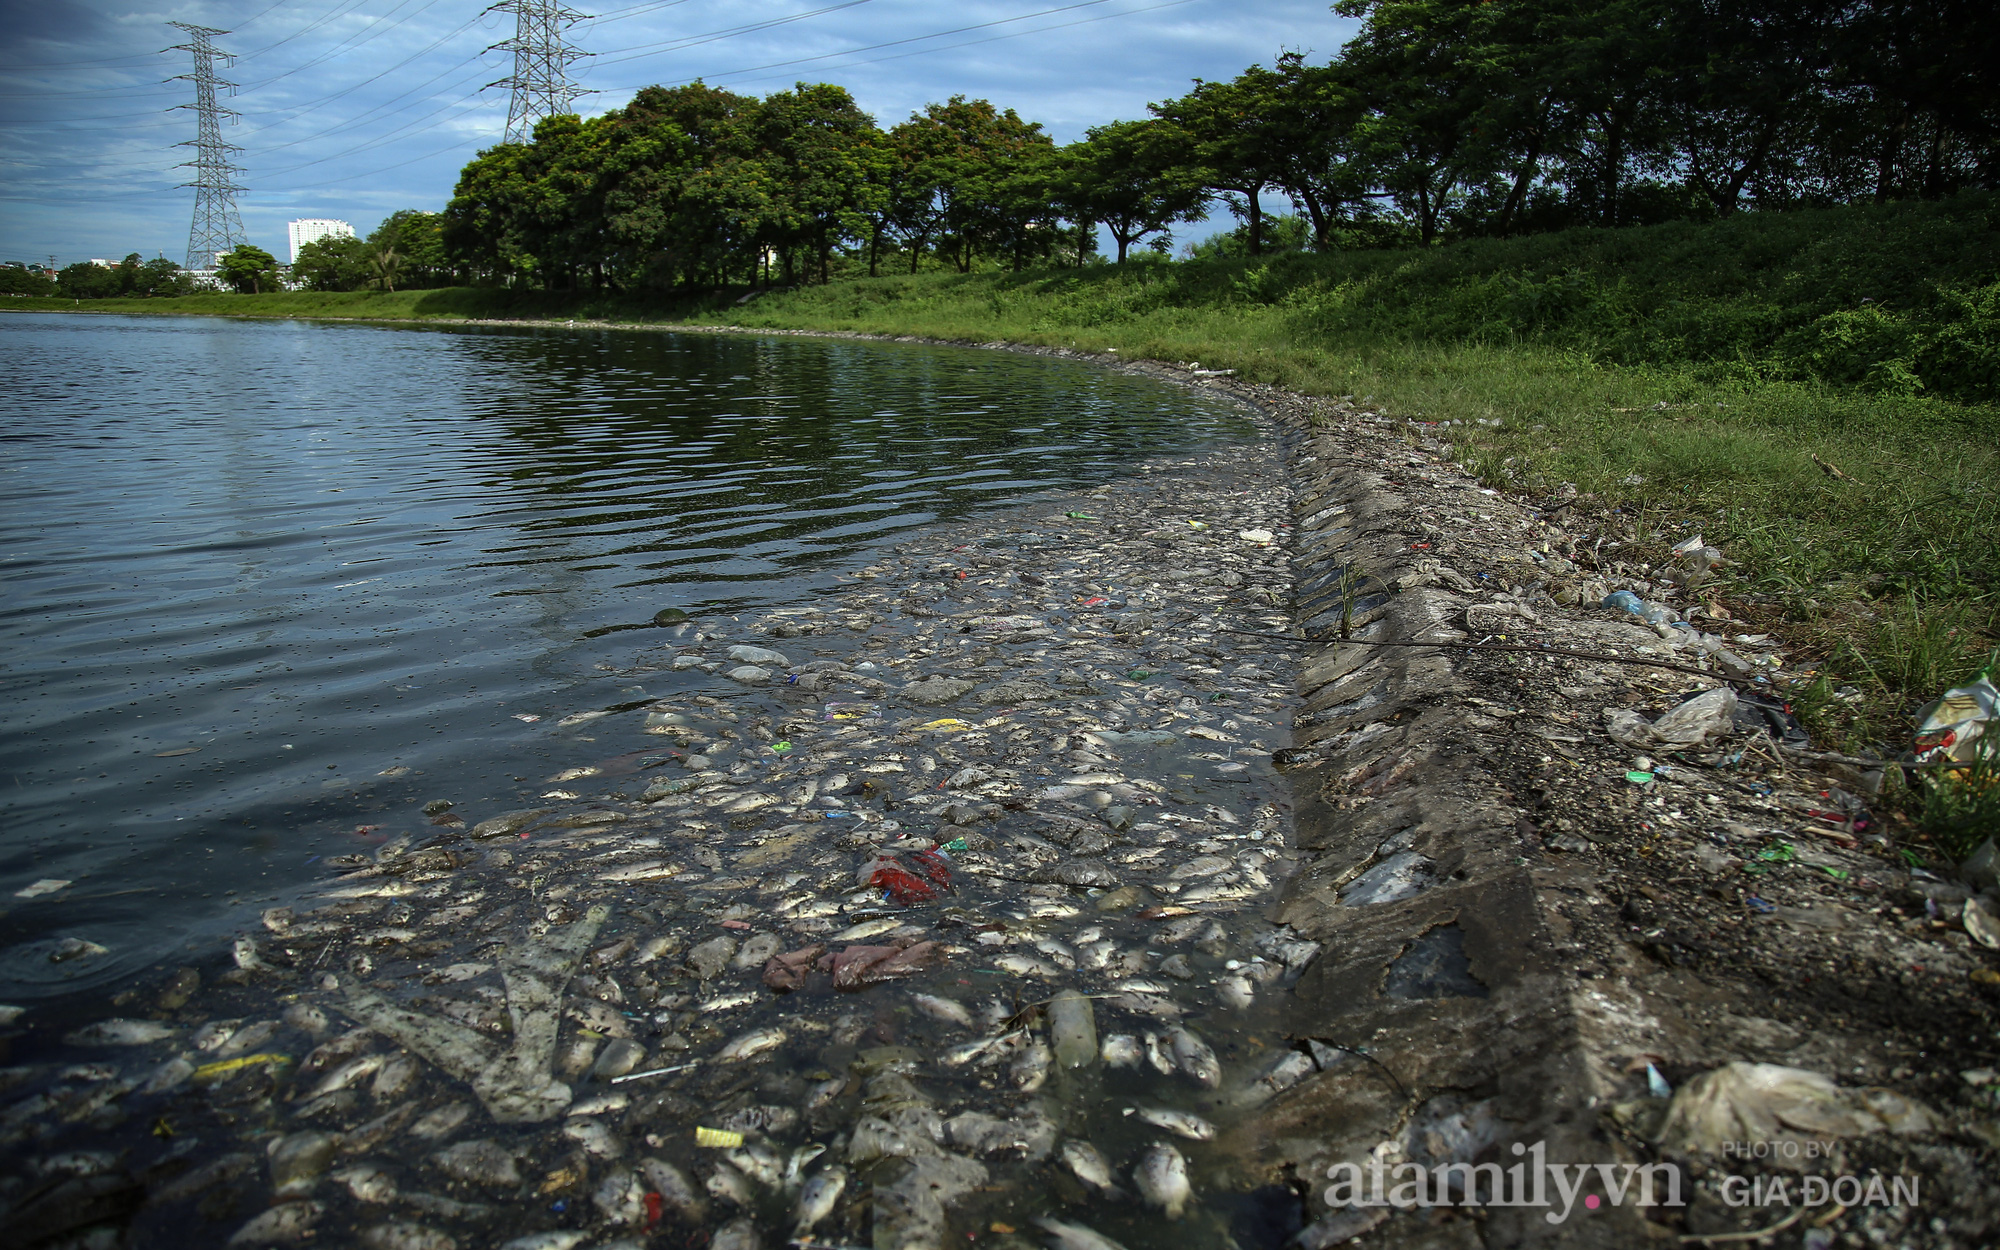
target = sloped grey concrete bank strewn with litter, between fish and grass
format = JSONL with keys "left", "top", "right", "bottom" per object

{"left": 1244, "top": 388, "right": 2000, "bottom": 1248}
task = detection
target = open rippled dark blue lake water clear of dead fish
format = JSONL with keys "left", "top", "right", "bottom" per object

{"left": 0, "top": 314, "right": 1248, "bottom": 1002}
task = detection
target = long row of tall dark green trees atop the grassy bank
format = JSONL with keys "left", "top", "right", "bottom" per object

{"left": 438, "top": 0, "right": 2000, "bottom": 290}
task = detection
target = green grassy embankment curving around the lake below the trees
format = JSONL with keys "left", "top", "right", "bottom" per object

{"left": 16, "top": 196, "right": 2000, "bottom": 842}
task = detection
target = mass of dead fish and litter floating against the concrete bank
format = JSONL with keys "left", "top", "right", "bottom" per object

{"left": 0, "top": 412, "right": 1344, "bottom": 1250}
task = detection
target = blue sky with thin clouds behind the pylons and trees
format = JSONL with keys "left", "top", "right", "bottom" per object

{"left": 0, "top": 0, "right": 1354, "bottom": 264}
